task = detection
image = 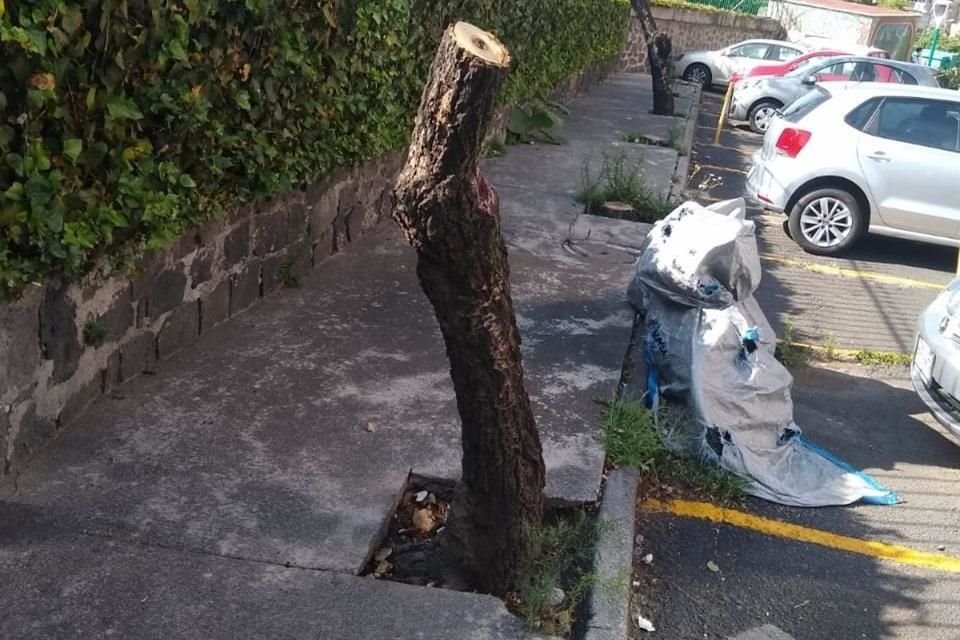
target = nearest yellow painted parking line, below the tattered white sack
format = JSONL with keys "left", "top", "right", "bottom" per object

{"left": 640, "top": 500, "right": 960, "bottom": 573}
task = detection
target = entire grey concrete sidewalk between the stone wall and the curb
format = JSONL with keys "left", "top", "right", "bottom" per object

{"left": 0, "top": 75, "right": 683, "bottom": 640}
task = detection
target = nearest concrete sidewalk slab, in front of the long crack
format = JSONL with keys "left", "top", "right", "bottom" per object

{"left": 0, "top": 531, "right": 533, "bottom": 640}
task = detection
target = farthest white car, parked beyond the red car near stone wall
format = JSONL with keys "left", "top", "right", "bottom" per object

{"left": 673, "top": 40, "right": 807, "bottom": 88}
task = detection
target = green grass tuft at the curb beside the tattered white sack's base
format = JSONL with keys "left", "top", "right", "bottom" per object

{"left": 603, "top": 400, "right": 747, "bottom": 502}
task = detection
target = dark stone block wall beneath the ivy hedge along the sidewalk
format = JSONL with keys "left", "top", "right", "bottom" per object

{"left": 0, "top": 59, "right": 618, "bottom": 477}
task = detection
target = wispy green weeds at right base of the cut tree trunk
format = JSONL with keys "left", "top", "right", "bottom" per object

{"left": 511, "top": 511, "right": 626, "bottom": 635}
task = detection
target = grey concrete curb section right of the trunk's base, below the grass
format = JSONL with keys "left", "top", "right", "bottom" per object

{"left": 583, "top": 469, "right": 640, "bottom": 640}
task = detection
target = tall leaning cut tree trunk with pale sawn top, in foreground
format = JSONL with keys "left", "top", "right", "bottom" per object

{"left": 393, "top": 22, "right": 544, "bottom": 594}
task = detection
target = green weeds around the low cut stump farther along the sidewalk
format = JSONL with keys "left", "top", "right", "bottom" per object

{"left": 576, "top": 153, "right": 675, "bottom": 222}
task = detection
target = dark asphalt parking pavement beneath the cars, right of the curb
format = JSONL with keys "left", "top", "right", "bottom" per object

{"left": 634, "top": 94, "right": 960, "bottom": 640}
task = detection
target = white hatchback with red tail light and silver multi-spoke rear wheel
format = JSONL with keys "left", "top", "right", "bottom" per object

{"left": 747, "top": 83, "right": 960, "bottom": 255}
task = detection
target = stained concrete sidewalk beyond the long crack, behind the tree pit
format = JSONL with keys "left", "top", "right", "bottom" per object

{"left": 0, "top": 77, "right": 675, "bottom": 573}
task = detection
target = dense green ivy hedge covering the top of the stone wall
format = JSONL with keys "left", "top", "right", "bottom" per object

{"left": 0, "top": 0, "right": 629, "bottom": 298}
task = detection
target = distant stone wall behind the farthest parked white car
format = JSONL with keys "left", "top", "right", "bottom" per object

{"left": 620, "top": 6, "right": 786, "bottom": 72}
